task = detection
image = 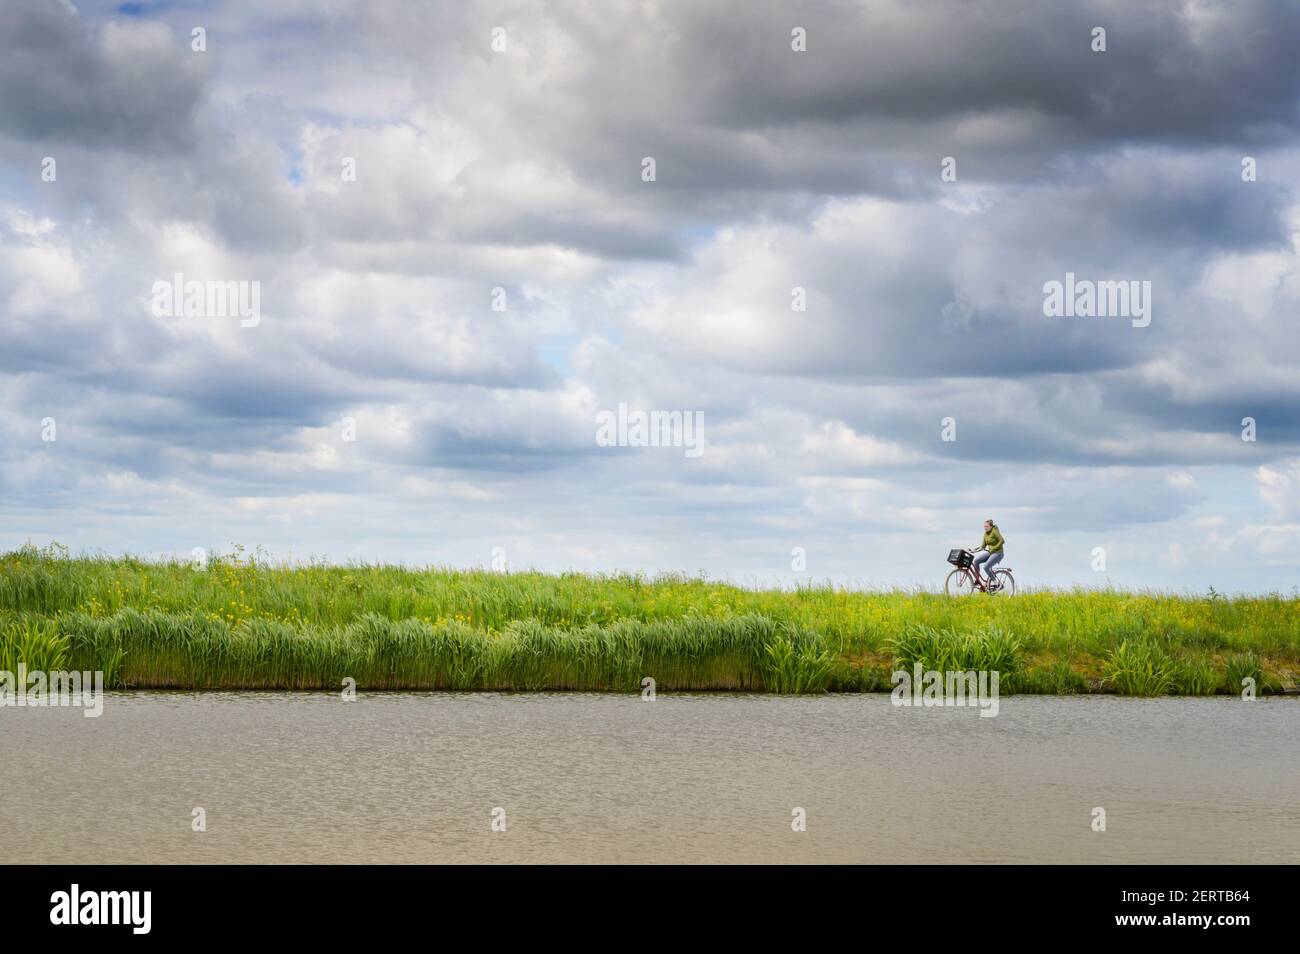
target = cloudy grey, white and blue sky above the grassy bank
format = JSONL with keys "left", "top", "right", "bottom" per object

{"left": 0, "top": 0, "right": 1300, "bottom": 591}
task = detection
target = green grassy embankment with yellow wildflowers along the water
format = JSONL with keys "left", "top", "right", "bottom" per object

{"left": 0, "top": 547, "right": 1300, "bottom": 695}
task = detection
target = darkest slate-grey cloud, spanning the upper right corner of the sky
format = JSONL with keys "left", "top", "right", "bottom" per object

{"left": 658, "top": 0, "right": 1300, "bottom": 147}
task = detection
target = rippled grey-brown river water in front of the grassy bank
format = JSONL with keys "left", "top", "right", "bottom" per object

{"left": 0, "top": 693, "right": 1300, "bottom": 863}
